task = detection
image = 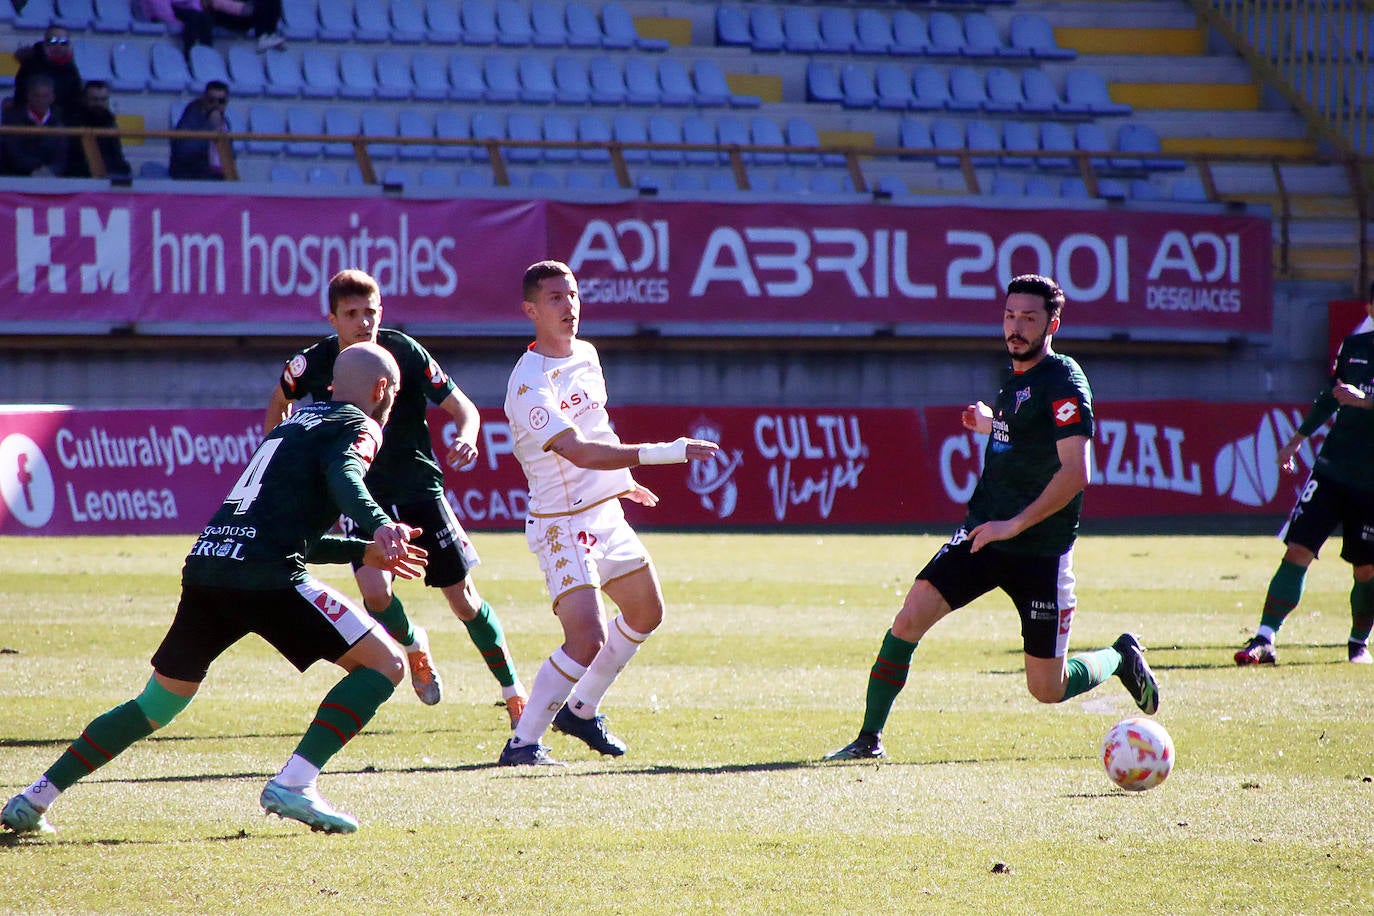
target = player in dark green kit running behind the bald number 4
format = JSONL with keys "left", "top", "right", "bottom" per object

{"left": 264, "top": 271, "right": 526, "bottom": 728}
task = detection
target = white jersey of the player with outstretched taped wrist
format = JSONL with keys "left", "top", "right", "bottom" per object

{"left": 506, "top": 341, "right": 633, "bottom": 516}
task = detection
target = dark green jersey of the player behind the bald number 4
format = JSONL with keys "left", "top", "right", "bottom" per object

{"left": 282, "top": 328, "right": 458, "bottom": 505}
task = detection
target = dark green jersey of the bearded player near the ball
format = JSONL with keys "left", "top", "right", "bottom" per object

{"left": 963, "top": 353, "right": 1092, "bottom": 556}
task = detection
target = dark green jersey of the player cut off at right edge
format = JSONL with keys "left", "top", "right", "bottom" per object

{"left": 1298, "top": 331, "right": 1374, "bottom": 492}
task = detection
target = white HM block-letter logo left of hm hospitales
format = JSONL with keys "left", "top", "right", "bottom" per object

{"left": 14, "top": 207, "right": 132, "bottom": 293}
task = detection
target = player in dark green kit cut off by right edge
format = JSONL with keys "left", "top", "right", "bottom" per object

{"left": 1235, "top": 286, "right": 1374, "bottom": 665}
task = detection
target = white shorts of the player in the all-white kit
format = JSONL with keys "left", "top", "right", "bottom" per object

{"left": 525, "top": 500, "right": 649, "bottom": 604}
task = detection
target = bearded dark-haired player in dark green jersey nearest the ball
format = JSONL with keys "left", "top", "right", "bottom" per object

{"left": 826, "top": 275, "right": 1160, "bottom": 759}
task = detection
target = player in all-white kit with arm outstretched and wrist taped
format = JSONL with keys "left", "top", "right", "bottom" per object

{"left": 499, "top": 261, "right": 719, "bottom": 766}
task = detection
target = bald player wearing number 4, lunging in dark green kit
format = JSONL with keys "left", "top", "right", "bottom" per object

{"left": 0, "top": 343, "right": 425, "bottom": 834}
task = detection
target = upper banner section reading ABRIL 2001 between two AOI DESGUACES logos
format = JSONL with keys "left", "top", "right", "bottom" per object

{"left": 548, "top": 201, "right": 1272, "bottom": 336}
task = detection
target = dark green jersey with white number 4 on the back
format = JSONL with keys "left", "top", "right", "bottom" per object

{"left": 181, "top": 401, "right": 390, "bottom": 589}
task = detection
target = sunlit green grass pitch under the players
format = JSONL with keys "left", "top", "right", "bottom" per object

{"left": 0, "top": 533, "right": 1374, "bottom": 913}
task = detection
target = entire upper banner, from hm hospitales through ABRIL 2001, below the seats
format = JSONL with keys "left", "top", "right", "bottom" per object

{"left": 0, "top": 192, "right": 1272, "bottom": 339}
